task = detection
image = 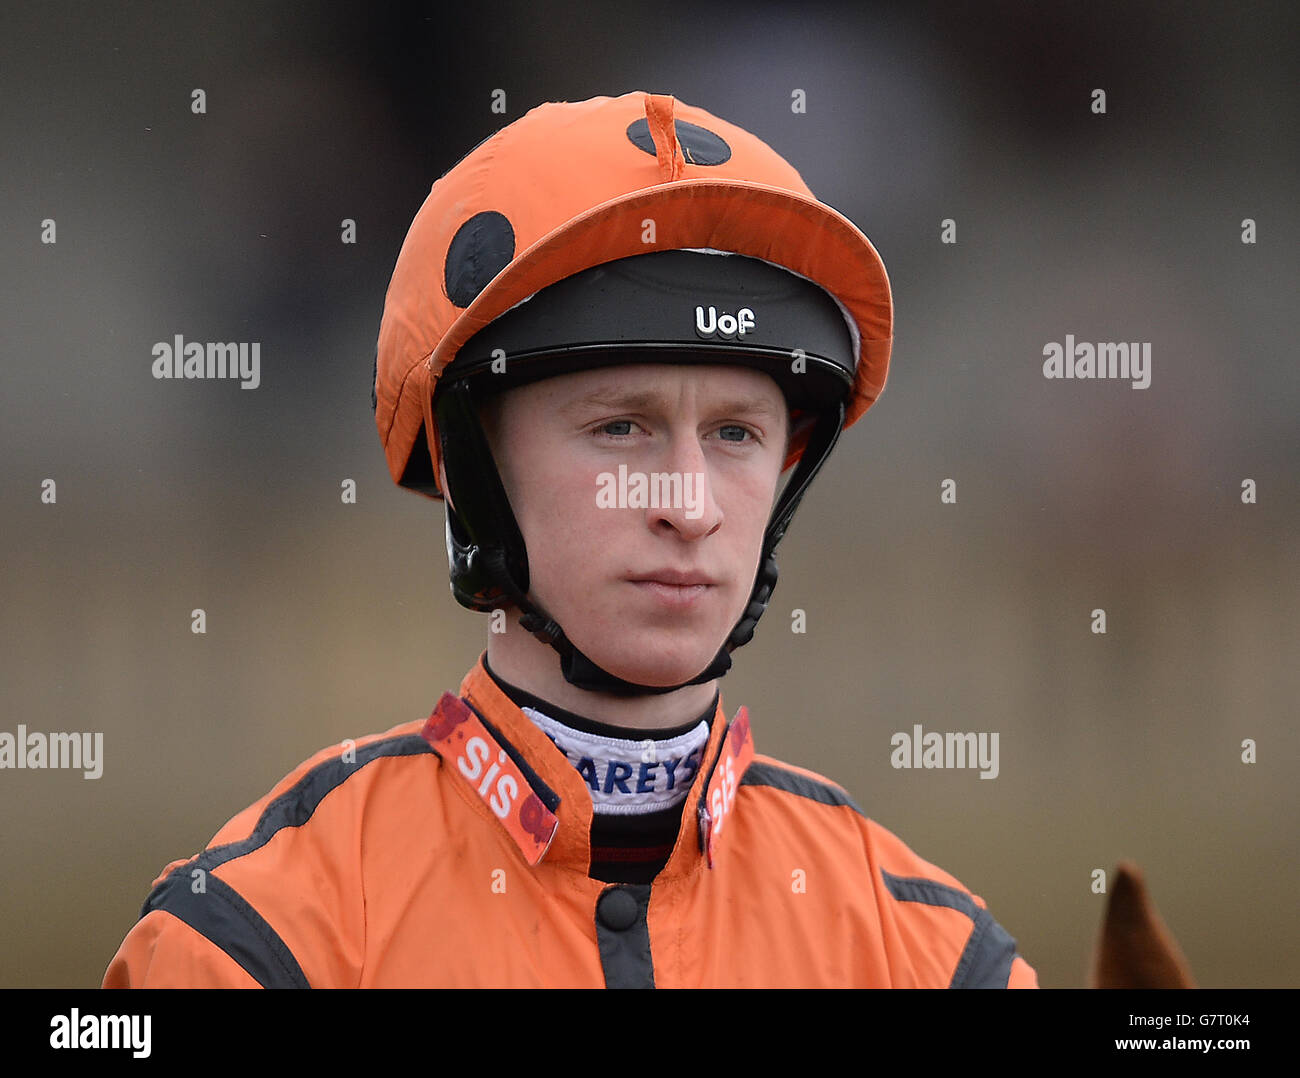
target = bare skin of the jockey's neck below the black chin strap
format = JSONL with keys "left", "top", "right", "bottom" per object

{"left": 488, "top": 619, "right": 718, "bottom": 731}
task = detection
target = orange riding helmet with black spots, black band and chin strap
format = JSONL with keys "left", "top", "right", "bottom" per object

{"left": 373, "top": 91, "right": 893, "bottom": 694}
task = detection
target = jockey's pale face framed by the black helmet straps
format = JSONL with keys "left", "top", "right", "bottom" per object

{"left": 485, "top": 364, "right": 789, "bottom": 687}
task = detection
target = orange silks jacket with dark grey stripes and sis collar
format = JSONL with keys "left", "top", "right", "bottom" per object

{"left": 104, "top": 658, "right": 1037, "bottom": 988}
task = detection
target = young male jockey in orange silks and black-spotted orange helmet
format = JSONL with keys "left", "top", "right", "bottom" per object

{"left": 105, "top": 92, "right": 1036, "bottom": 987}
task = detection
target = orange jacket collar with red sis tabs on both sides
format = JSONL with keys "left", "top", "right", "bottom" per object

{"left": 423, "top": 655, "right": 754, "bottom": 879}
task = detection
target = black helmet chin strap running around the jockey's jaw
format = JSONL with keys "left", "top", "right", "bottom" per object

{"left": 438, "top": 382, "right": 845, "bottom": 697}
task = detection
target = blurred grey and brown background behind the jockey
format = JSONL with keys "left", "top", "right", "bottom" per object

{"left": 0, "top": 0, "right": 1300, "bottom": 987}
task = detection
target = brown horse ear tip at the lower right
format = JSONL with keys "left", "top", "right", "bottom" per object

{"left": 1088, "top": 861, "right": 1196, "bottom": 988}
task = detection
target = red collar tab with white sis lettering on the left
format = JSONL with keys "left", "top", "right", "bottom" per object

{"left": 420, "top": 693, "right": 559, "bottom": 865}
